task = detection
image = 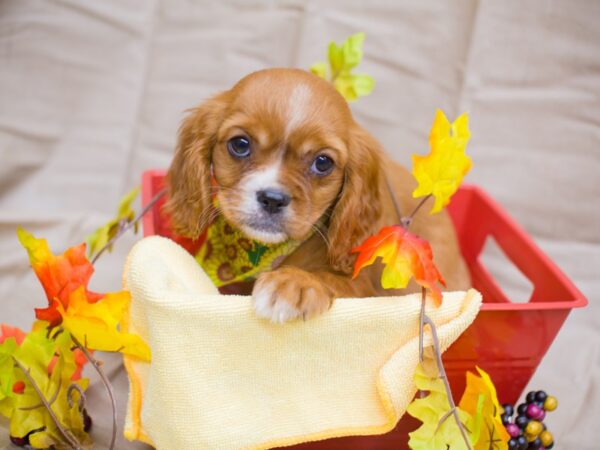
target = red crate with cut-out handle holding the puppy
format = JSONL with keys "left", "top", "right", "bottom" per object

{"left": 142, "top": 170, "right": 587, "bottom": 450}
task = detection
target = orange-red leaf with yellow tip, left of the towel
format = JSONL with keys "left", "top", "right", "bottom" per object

{"left": 17, "top": 227, "right": 102, "bottom": 327}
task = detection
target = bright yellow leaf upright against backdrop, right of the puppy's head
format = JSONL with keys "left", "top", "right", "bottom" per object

{"left": 412, "top": 109, "right": 472, "bottom": 213}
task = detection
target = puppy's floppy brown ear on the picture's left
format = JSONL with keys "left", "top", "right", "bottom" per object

{"left": 165, "top": 92, "right": 228, "bottom": 239}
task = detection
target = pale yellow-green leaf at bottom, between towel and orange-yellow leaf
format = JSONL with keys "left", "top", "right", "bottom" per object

{"left": 406, "top": 358, "right": 473, "bottom": 450}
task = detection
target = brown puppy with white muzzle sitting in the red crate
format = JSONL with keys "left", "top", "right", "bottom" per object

{"left": 166, "top": 69, "right": 470, "bottom": 322}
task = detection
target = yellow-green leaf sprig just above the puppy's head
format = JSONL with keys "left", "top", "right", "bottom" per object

{"left": 310, "top": 33, "right": 375, "bottom": 102}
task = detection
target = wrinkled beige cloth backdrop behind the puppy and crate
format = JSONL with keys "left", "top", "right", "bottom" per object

{"left": 0, "top": 0, "right": 600, "bottom": 450}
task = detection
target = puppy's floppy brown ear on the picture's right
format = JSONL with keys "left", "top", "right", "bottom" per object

{"left": 328, "top": 125, "right": 382, "bottom": 273}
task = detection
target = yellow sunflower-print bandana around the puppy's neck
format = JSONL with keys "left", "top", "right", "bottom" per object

{"left": 195, "top": 216, "right": 300, "bottom": 287}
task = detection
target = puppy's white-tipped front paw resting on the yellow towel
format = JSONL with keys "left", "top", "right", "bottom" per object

{"left": 252, "top": 267, "right": 333, "bottom": 323}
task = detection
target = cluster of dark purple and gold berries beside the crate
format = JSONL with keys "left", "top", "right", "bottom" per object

{"left": 502, "top": 391, "right": 558, "bottom": 450}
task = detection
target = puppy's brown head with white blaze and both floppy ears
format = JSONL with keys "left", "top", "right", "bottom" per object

{"left": 166, "top": 69, "right": 381, "bottom": 272}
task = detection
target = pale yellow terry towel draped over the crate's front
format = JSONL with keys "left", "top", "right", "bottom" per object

{"left": 124, "top": 237, "right": 481, "bottom": 450}
